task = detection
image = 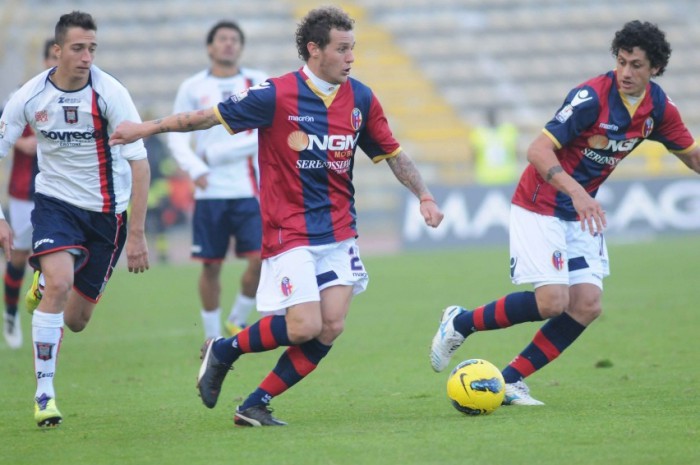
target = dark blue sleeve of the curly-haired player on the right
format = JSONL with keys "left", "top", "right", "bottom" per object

{"left": 544, "top": 86, "right": 600, "bottom": 148}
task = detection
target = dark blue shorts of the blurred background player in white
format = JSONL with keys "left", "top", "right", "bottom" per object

{"left": 192, "top": 198, "right": 262, "bottom": 261}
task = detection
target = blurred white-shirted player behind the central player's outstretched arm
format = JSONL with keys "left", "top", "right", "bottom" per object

{"left": 168, "top": 21, "right": 267, "bottom": 338}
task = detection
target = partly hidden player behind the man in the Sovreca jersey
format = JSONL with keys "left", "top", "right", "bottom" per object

{"left": 3, "top": 39, "right": 57, "bottom": 349}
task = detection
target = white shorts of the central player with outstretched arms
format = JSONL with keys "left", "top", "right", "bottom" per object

{"left": 256, "top": 239, "right": 369, "bottom": 313}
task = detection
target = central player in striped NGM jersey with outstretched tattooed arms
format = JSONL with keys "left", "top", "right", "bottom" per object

{"left": 110, "top": 7, "right": 443, "bottom": 426}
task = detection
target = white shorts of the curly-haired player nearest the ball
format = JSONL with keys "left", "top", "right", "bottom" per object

{"left": 510, "top": 205, "right": 610, "bottom": 290}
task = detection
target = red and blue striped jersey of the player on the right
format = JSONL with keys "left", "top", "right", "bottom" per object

{"left": 513, "top": 71, "right": 696, "bottom": 221}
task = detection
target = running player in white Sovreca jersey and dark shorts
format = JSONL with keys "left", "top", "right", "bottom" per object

{"left": 0, "top": 11, "right": 150, "bottom": 427}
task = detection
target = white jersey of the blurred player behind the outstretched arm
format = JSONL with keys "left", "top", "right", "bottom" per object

{"left": 168, "top": 68, "right": 267, "bottom": 199}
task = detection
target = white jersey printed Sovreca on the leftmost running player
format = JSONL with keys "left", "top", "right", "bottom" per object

{"left": 0, "top": 66, "right": 146, "bottom": 213}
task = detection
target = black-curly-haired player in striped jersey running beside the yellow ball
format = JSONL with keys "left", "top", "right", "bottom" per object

{"left": 430, "top": 21, "right": 700, "bottom": 405}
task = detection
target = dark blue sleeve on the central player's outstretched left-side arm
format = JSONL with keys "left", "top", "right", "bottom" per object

{"left": 214, "top": 81, "right": 276, "bottom": 134}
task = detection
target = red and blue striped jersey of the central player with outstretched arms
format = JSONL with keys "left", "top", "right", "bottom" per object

{"left": 214, "top": 70, "right": 401, "bottom": 258}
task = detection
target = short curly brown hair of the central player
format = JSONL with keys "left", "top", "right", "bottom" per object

{"left": 296, "top": 6, "right": 355, "bottom": 62}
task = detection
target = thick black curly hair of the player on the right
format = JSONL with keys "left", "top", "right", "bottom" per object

{"left": 610, "top": 20, "right": 671, "bottom": 76}
